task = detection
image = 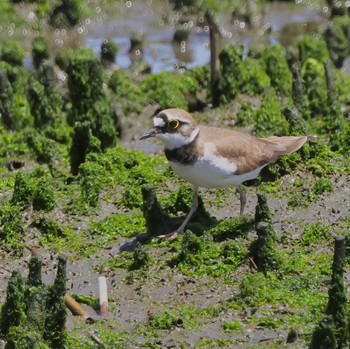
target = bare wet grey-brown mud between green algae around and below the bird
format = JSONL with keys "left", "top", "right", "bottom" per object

{"left": 0, "top": 152, "right": 350, "bottom": 348}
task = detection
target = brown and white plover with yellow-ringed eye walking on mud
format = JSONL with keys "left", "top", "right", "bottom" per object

{"left": 140, "top": 108, "right": 315, "bottom": 238}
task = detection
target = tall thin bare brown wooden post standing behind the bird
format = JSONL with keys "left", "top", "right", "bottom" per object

{"left": 205, "top": 10, "right": 221, "bottom": 107}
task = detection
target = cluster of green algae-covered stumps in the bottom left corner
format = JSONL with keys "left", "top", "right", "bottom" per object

{"left": 0, "top": 256, "right": 66, "bottom": 349}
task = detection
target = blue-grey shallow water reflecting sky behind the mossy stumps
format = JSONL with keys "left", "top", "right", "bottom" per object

{"left": 84, "top": 1, "right": 327, "bottom": 73}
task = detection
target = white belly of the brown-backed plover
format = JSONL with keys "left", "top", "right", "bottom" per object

{"left": 170, "top": 158, "right": 266, "bottom": 188}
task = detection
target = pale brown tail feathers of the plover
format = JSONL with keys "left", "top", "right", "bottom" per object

{"left": 262, "top": 135, "right": 316, "bottom": 158}
